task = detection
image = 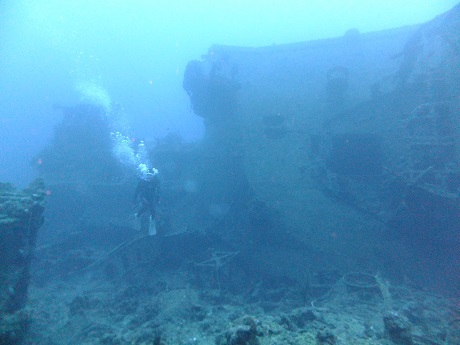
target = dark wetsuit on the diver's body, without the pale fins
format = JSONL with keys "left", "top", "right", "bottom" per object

{"left": 134, "top": 174, "right": 160, "bottom": 219}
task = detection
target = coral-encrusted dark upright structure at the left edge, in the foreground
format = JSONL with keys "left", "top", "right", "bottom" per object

{"left": 0, "top": 180, "right": 46, "bottom": 344}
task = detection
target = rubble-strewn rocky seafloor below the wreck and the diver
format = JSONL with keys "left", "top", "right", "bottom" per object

{"left": 26, "top": 231, "right": 460, "bottom": 345}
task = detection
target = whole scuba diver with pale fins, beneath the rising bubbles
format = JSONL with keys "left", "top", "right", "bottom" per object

{"left": 133, "top": 164, "right": 160, "bottom": 235}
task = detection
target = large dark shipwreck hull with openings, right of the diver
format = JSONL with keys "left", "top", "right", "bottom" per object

{"left": 184, "top": 6, "right": 460, "bottom": 284}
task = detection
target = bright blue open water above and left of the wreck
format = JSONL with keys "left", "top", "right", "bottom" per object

{"left": 0, "top": 0, "right": 455, "bottom": 186}
